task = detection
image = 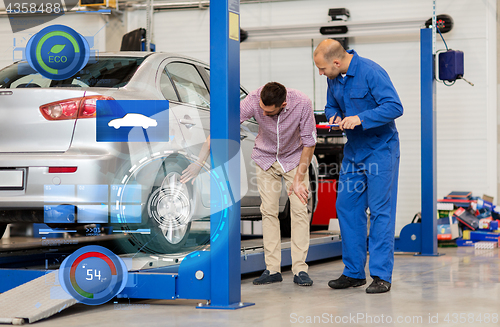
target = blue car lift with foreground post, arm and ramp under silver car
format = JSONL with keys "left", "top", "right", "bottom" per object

{"left": 0, "top": 0, "right": 341, "bottom": 324}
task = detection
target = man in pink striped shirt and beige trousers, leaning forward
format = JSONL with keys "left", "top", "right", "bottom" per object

{"left": 240, "top": 82, "right": 316, "bottom": 286}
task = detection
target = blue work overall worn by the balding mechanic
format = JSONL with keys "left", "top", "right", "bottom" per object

{"left": 325, "top": 50, "right": 403, "bottom": 282}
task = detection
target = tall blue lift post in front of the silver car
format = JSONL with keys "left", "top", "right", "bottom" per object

{"left": 198, "top": 0, "right": 253, "bottom": 309}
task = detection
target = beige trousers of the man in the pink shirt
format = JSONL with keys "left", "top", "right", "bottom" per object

{"left": 257, "top": 161, "right": 309, "bottom": 275}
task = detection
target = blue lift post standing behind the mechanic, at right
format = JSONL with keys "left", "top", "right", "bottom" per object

{"left": 395, "top": 28, "right": 439, "bottom": 256}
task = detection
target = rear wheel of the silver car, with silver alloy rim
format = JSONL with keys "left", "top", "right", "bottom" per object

{"left": 115, "top": 157, "right": 194, "bottom": 254}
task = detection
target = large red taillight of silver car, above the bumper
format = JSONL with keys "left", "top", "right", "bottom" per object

{"left": 40, "top": 95, "right": 114, "bottom": 120}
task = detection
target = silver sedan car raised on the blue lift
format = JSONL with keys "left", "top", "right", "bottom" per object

{"left": 0, "top": 52, "right": 318, "bottom": 253}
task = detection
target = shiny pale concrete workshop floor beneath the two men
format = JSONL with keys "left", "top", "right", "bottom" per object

{"left": 27, "top": 248, "right": 500, "bottom": 327}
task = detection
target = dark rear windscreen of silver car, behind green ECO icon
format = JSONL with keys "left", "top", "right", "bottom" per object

{"left": 0, "top": 57, "right": 146, "bottom": 89}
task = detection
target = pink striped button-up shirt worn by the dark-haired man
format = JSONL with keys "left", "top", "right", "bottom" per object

{"left": 240, "top": 87, "right": 316, "bottom": 172}
